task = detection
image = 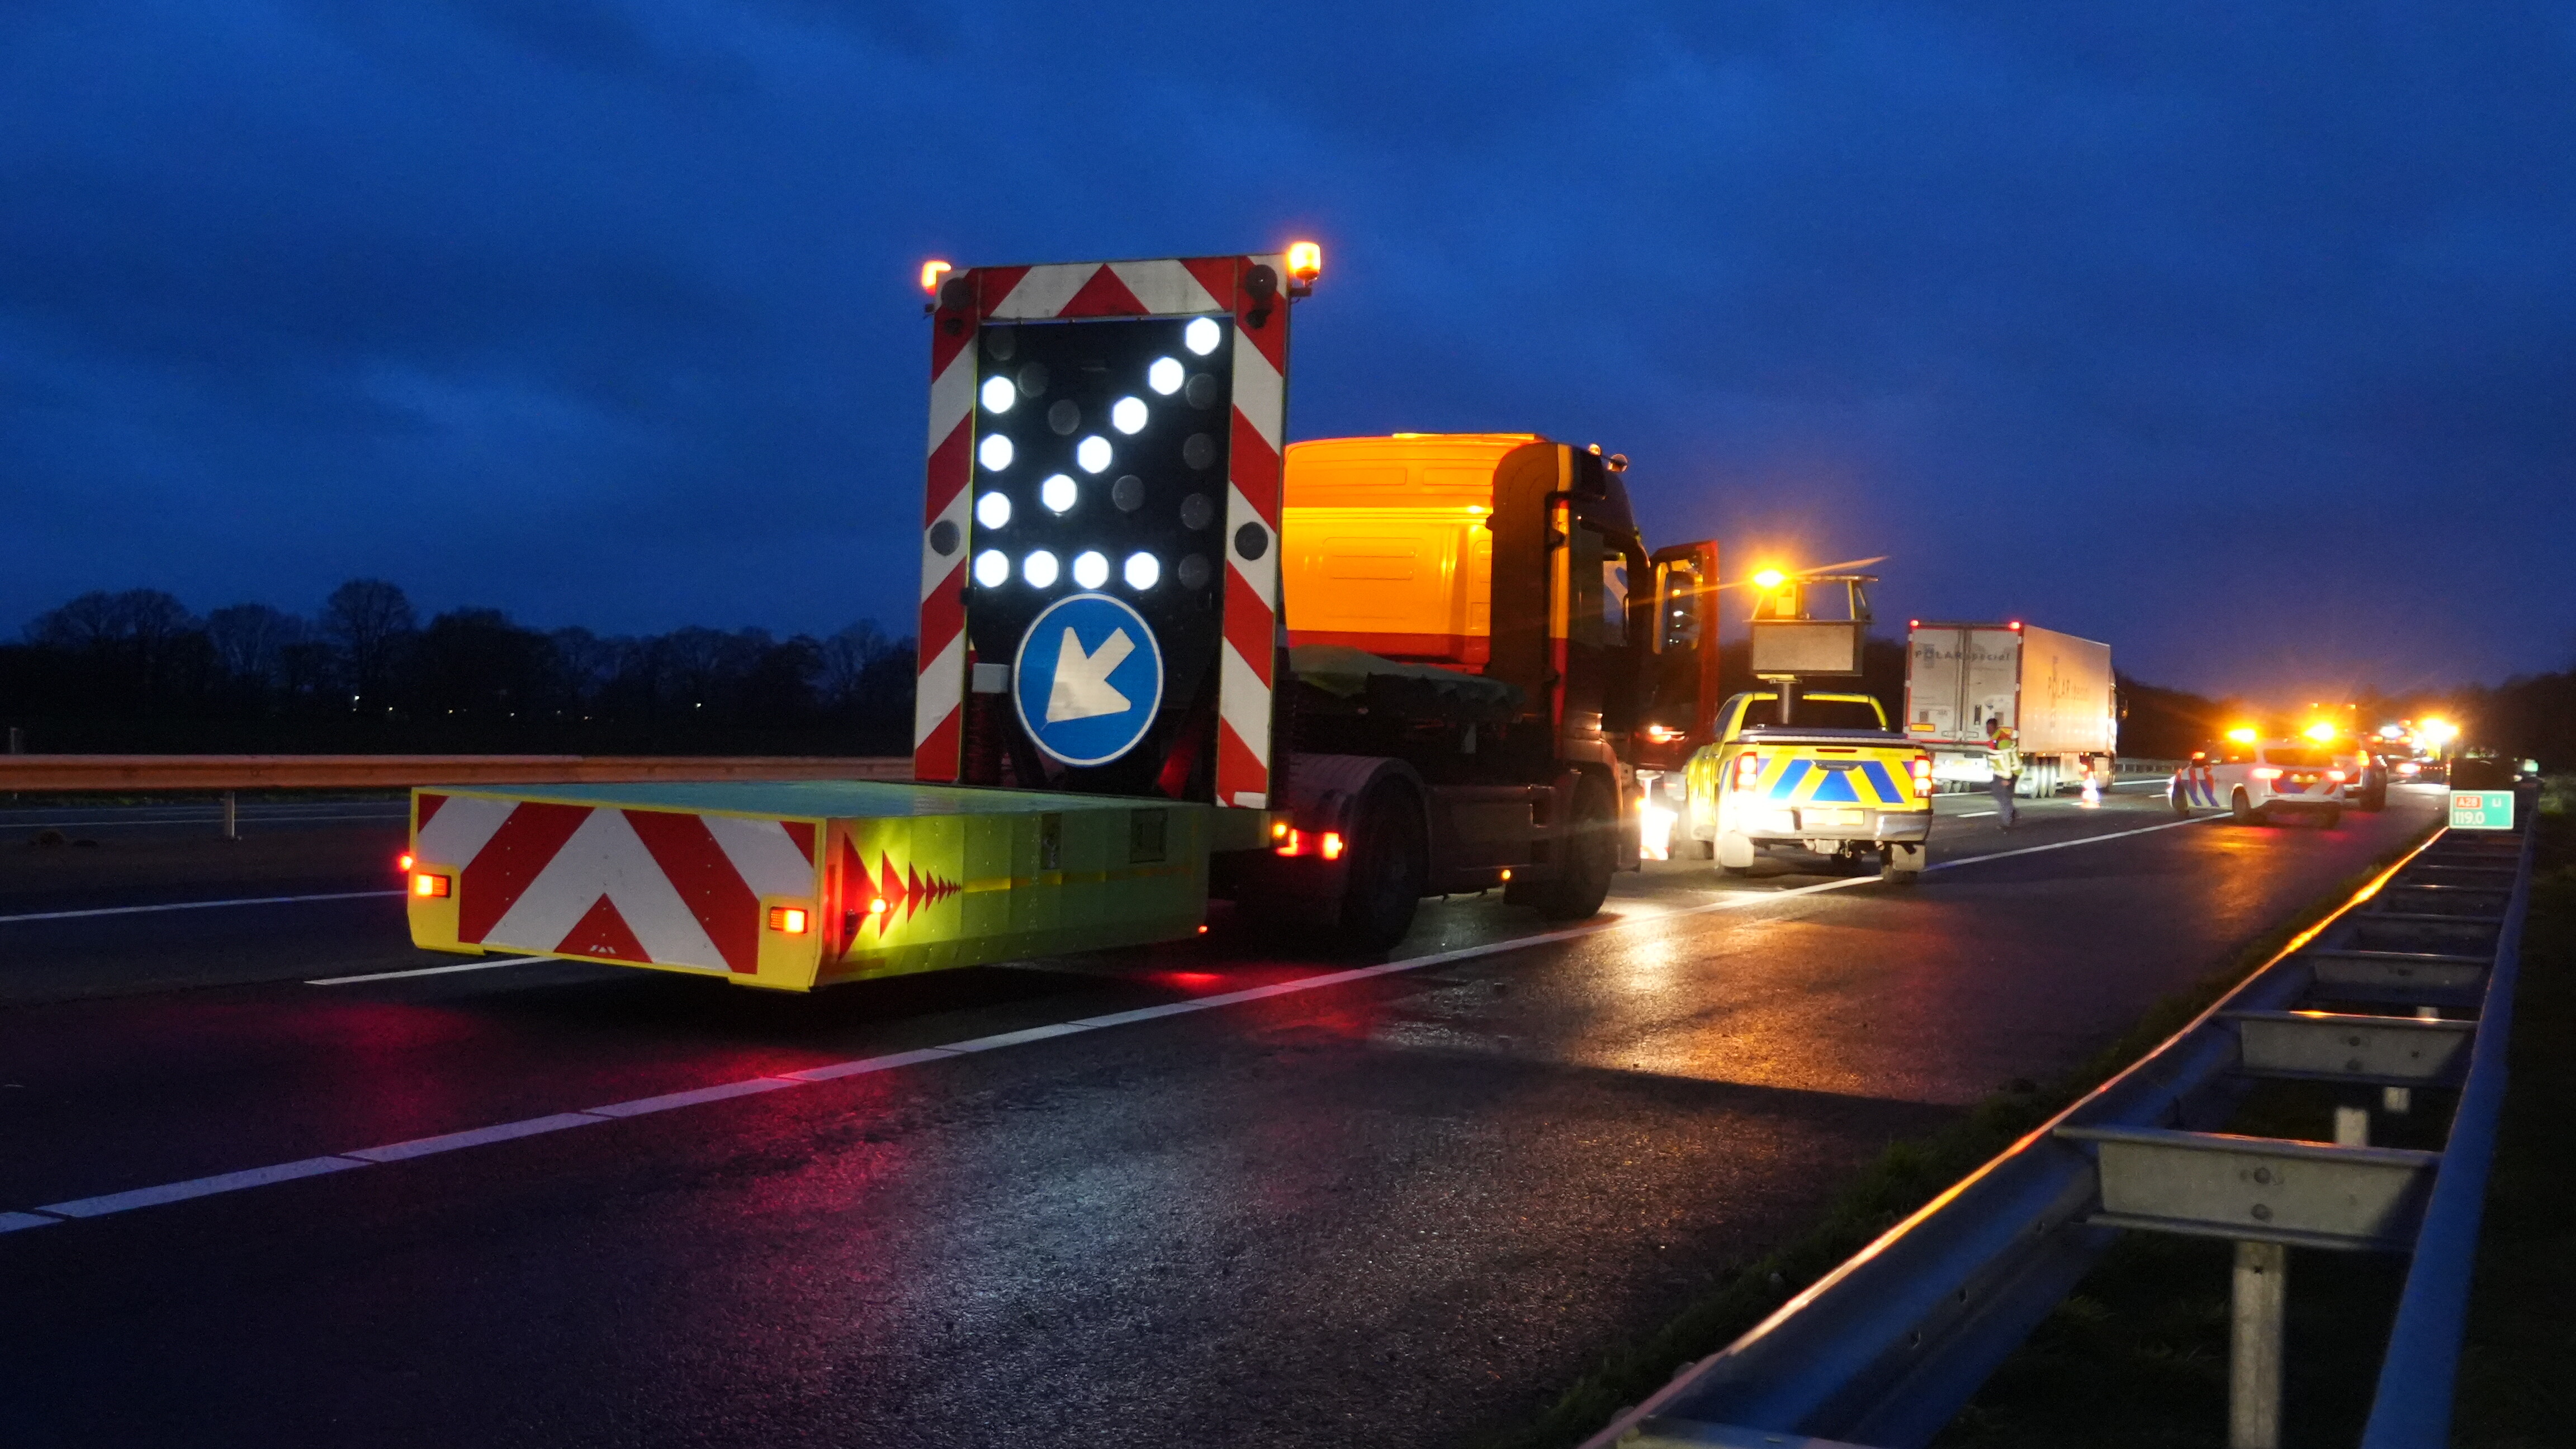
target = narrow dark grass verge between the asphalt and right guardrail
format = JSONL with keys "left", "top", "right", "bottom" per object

{"left": 1484, "top": 820, "right": 2422, "bottom": 1449}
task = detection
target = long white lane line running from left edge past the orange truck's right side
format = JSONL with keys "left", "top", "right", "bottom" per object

{"left": 0, "top": 815, "right": 2223, "bottom": 1233}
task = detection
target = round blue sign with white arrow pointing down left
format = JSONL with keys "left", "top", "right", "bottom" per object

{"left": 1010, "top": 593, "right": 1162, "bottom": 766}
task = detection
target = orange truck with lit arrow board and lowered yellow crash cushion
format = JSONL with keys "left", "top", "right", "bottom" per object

{"left": 410, "top": 248, "right": 1718, "bottom": 990}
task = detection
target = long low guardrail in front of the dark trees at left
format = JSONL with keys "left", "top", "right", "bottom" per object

{"left": 0, "top": 755, "right": 912, "bottom": 792}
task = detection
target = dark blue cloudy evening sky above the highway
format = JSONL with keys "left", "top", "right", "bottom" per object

{"left": 0, "top": 0, "right": 2576, "bottom": 699}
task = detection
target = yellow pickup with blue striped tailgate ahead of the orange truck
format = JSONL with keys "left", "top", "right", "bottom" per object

{"left": 1682, "top": 691, "right": 1932, "bottom": 882}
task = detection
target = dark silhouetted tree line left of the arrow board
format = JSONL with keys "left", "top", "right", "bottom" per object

{"left": 0, "top": 577, "right": 912, "bottom": 755}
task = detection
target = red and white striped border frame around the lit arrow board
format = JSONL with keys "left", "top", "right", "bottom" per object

{"left": 912, "top": 255, "right": 1288, "bottom": 807}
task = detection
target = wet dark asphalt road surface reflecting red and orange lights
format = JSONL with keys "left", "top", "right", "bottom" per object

{"left": 0, "top": 792, "right": 2440, "bottom": 1446}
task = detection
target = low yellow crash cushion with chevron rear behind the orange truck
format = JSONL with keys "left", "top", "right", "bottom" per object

{"left": 407, "top": 781, "right": 1219, "bottom": 990}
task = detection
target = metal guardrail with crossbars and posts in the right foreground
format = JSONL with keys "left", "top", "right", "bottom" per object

{"left": 1584, "top": 799, "right": 2532, "bottom": 1449}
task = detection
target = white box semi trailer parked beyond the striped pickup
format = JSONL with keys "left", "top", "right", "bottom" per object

{"left": 1906, "top": 619, "right": 2120, "bottom": 794}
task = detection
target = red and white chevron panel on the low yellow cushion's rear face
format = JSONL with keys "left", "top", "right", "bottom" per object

{"left": 412, "top": 794, "right": 817, "bottom": 974}
